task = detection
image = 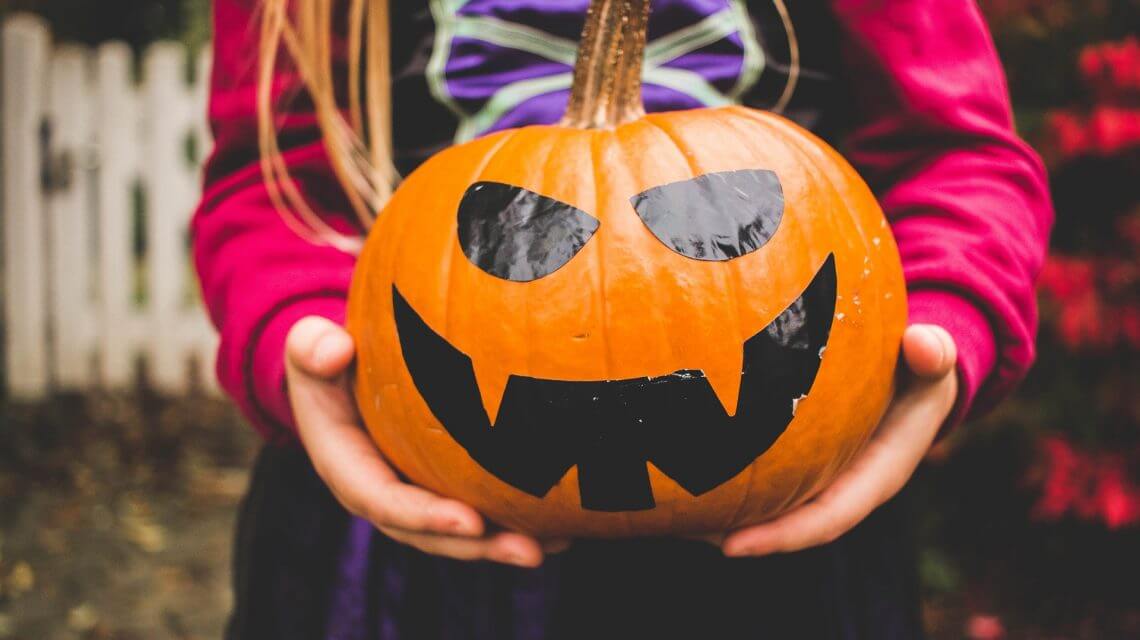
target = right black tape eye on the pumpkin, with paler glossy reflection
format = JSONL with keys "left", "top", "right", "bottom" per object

{"left": 629, "top": 169, "right": 784, "bottom": 260}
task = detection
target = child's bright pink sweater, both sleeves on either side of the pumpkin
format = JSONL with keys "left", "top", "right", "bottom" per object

{"left": 193, "top": 0, "right": 1052, "bottom": 441}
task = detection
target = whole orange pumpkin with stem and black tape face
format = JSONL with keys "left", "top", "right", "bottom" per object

{"left": 348, "top": 0, "right": 906, "bottom": 536}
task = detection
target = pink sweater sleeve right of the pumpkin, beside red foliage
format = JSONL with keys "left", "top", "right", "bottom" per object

{"left": 836, "top": 0, "right": 1053, "bottom": 423}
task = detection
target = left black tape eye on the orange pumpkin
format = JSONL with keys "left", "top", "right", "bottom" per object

{"left": 459, "top": 183, "right": 597, "bottom": 282}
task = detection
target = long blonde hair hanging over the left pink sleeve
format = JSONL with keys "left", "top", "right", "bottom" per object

{"left": 258, "top": 0, "right": 396, "bottom": 253}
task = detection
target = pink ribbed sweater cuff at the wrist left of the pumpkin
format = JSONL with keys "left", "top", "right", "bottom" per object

{"left": 251, "top": 295, "right": 345, "bottom": 444}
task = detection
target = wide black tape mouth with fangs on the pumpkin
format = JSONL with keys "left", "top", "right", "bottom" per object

{"left": 392, "top": 256, "right": 837, "bottom": 511}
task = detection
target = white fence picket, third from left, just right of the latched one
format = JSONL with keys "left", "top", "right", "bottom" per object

{"left": 96, "top": 42, "right": 141, "bottom": 388}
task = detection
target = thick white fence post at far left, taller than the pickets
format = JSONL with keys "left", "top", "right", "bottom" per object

{"left": 2, "top": 15, "right": 50, "bottom": 398}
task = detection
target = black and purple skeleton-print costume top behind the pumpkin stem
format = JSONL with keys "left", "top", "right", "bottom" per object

{"left": 391, "top": 0, "right": 848, "bottom": 171}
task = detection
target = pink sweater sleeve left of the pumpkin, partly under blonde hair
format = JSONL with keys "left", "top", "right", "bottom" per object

{"left": 192, "top": 0, "right": 355, "bottom": 441}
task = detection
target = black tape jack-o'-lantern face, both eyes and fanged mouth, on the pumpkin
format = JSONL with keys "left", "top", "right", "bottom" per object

{"left": 392, "top": 169, "right": 836, "bottom": 511}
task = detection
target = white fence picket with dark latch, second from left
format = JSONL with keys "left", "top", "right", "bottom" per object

{"left": 48, "top": 47, "right": 95, "bottom": 389}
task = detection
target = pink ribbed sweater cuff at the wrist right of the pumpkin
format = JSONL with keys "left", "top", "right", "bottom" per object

{"left": 907, "top": 289, "right": 998, "bottom": 434}
